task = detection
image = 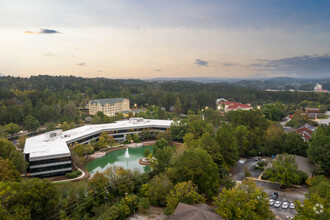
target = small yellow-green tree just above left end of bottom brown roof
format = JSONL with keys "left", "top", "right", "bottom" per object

{"left": 166, "top": 181, "right": 206, "bottom": 214}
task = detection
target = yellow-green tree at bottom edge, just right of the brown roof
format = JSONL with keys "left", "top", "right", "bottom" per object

{"left": 214, "top": 180, "right": 275, "bottom": 220}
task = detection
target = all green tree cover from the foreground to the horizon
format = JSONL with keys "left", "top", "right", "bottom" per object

{"left": 0, "top": 76, "right": 330, "bottom": 219}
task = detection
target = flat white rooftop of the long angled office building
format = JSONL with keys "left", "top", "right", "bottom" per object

{"left": 24, "top": 118, "right": 173, "bottom": 161}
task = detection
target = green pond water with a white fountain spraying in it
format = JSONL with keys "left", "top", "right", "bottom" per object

{"left": 85, "top": 146, "right": 152, "bottom": 176}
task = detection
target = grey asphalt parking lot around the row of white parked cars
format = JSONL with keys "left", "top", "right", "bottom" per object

{"left": 256, "top": 181, "right": 307, "bottom": 219}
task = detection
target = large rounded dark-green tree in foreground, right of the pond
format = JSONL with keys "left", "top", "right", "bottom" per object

{"left": 168, "top": 148, "right": 220, "bottom": 198}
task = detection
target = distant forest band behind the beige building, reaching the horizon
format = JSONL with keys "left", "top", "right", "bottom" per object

{"left": 0, "top": 75, "right": 330, "bottom": 129}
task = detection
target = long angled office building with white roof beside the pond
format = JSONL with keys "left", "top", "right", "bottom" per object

{"left": 23, "top": 118, "right": 173, "bottom": 177}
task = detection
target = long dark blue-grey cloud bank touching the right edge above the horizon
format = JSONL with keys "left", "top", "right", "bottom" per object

{"left": 247, "top": 54, "right": 330, "bottom": 77}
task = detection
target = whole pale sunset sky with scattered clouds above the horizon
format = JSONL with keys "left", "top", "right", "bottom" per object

{"left": 0, "top": 0, "right": 330, "bottom": 79}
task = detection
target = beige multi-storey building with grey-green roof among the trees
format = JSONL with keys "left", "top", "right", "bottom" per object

{"left": 88, "top": 98, "right": 131, "bottom": 117}
